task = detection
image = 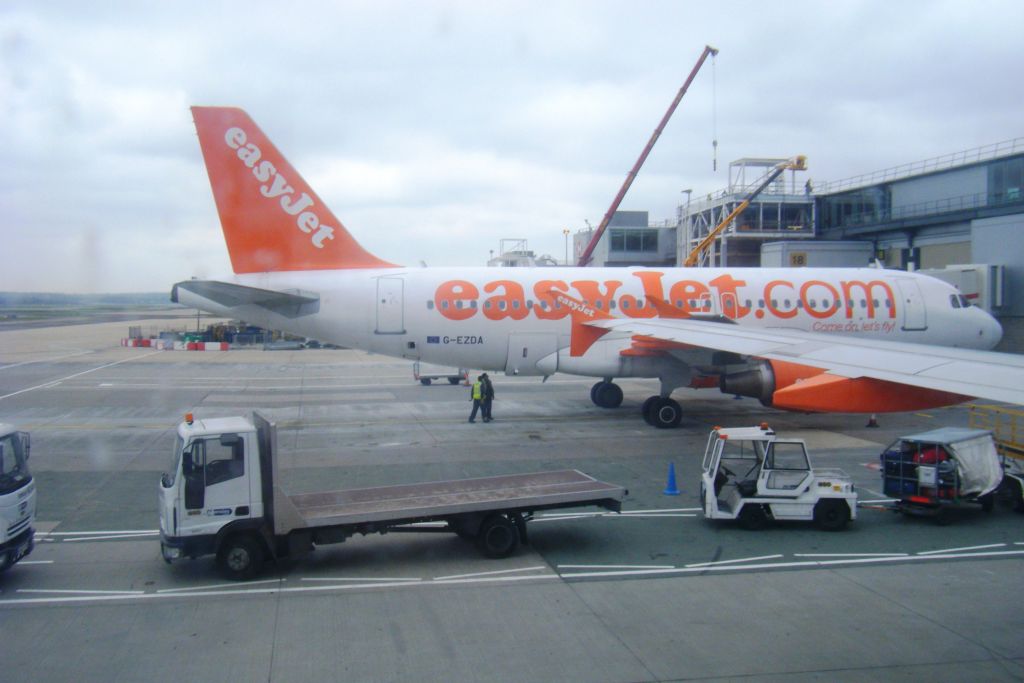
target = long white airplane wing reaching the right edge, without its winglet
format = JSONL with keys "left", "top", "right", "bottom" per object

{"left": 584, "top": 317, "right": 1024, "bottom": 404}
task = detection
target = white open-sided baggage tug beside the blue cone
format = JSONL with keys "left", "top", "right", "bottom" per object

{"left": 700, "top": 424, "right": 857, "bottom": 530}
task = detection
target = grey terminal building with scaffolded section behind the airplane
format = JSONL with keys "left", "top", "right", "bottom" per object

{"left": 573, "top": 138, "right": 1024, "bottom": 352}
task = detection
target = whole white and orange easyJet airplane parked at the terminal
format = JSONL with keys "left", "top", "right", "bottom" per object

{"left": 171, "top": 106, "right": 1024, "bottom": 428}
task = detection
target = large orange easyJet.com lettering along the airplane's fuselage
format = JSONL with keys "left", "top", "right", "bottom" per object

{"left": 434, "top": 270, "right": 897, "bottom": 325}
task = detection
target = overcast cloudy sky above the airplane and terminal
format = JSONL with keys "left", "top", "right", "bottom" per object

{"left": 0, "top": 0, "right": 1024, "bottom": 292}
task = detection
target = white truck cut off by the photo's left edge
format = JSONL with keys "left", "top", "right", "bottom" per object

{"left": 0, "top": 424, "right": 36, "bottom": 571}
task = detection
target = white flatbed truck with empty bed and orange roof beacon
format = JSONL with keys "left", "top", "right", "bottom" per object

{"left": 160, "top": 412, "right": 628, "bottom": 580}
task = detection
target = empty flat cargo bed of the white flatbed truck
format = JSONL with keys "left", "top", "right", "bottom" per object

{"left": 288, "top": 470, "right": 623, "bottom": 526}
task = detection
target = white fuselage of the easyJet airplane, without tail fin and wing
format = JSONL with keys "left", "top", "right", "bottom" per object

{"left": 180, "top": 267, "right": 1001, "bottom": 377}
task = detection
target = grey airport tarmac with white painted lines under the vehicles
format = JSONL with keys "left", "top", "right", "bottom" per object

{"left": 0, "top": 321, "right": 1024, "bottom": 682}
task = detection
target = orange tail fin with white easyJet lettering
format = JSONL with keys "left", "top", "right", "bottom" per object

{"left": 191, "top": 106, "right": 394, "bottom": 272}
